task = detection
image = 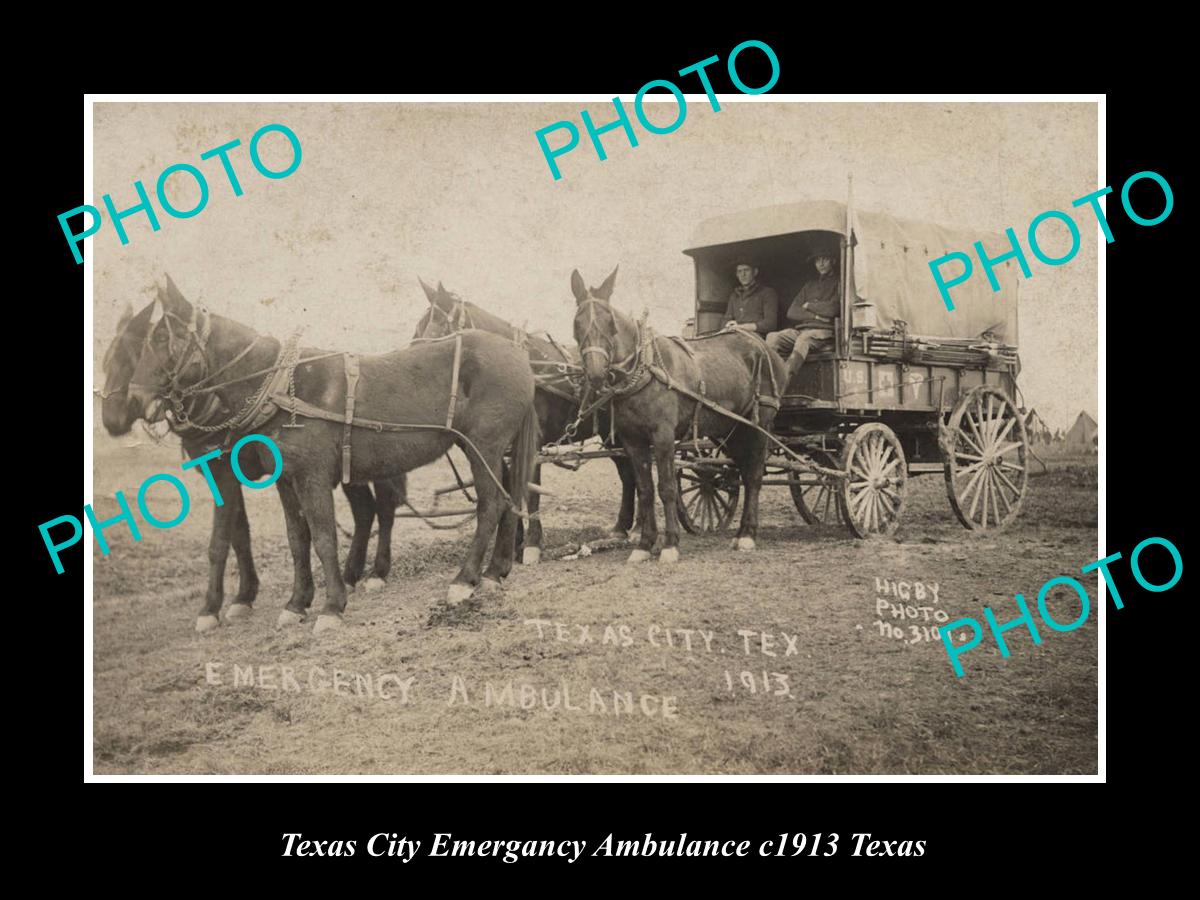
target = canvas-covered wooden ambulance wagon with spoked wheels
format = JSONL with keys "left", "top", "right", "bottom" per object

{"left": 684, "top": 202, "right": 1027, "bottom": 536}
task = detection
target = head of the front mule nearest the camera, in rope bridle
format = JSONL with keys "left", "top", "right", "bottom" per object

{"left": 127, "top": 276, "right": 209, "bottom": 421}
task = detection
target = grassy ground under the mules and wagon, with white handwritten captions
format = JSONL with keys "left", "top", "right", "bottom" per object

{"left": 92, "top": 437, "right": 1097, "bottom": 774}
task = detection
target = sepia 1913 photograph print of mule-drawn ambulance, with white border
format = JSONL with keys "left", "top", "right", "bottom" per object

{"left": 84, "top": 97, "right": 1099, "bottom": 776}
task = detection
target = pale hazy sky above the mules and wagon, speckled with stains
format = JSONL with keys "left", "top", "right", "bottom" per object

{"left": 88, "top": 95, "right": 1099, "bottom": 428}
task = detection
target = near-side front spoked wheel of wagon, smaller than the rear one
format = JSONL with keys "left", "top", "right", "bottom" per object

{"left": 838, "top": 422, "right": 908, "bottom": 538}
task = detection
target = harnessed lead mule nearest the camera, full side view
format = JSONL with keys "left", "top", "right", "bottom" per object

{"left": 128, "top": 283, "right": 539, "bottom": 631}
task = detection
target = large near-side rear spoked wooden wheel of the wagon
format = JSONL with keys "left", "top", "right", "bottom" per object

{"left": 941, "top": 384, "right": 1030, "bottom": 530}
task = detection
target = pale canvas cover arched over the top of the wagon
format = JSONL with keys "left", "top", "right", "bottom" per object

{"left": 685, "top": 200, "right": 1021, "bottom": 346}
